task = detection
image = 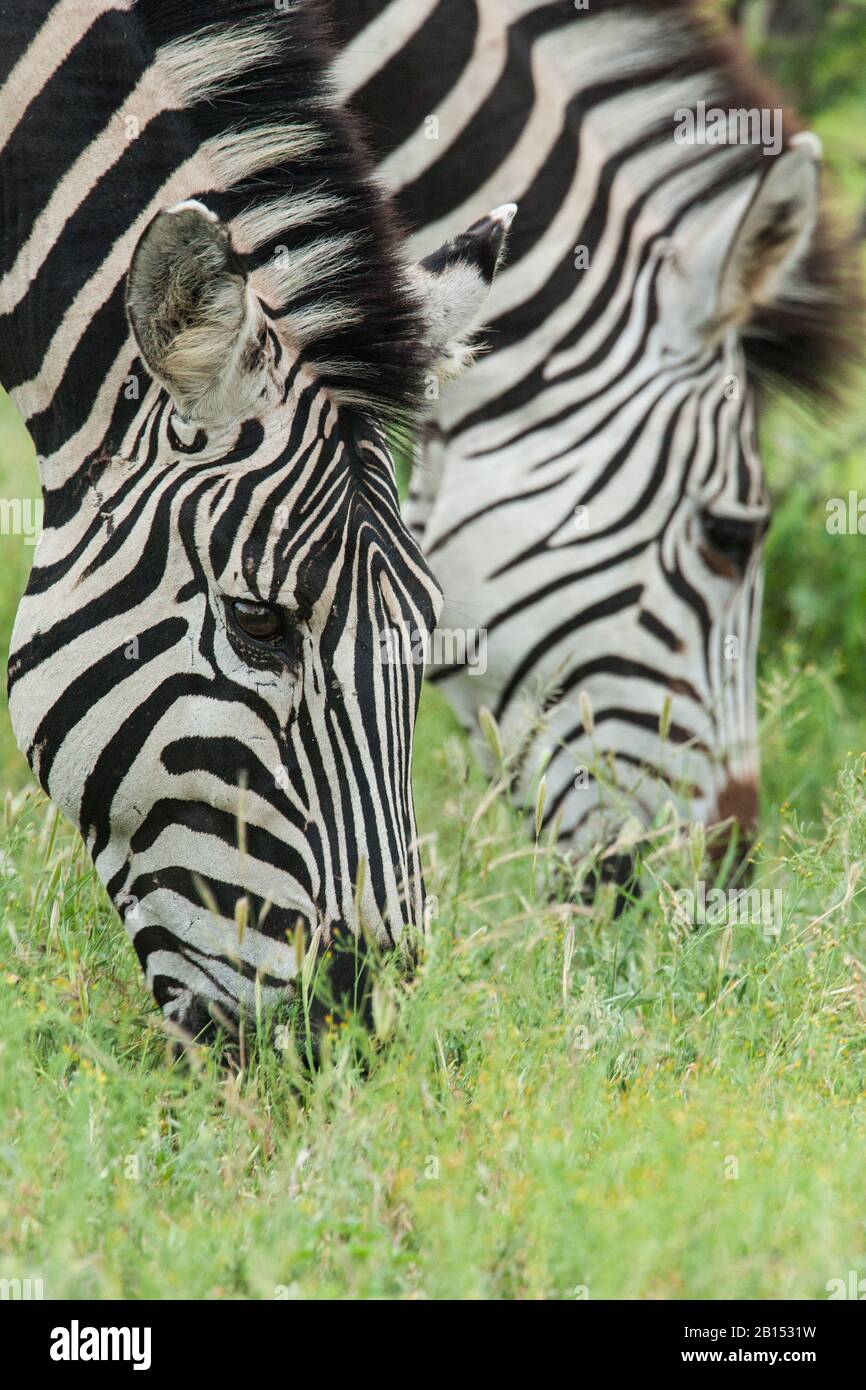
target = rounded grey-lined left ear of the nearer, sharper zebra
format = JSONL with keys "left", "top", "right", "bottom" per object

{"left": 126, "top": 202, "right": 264, "bottom": 420}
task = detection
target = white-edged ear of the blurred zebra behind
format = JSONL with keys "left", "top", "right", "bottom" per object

{"left": 659, "top": 135, "right": 822, "bottom": 346}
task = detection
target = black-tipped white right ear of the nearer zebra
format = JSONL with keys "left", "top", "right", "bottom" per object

{"left": 410, "top": 203, "right": 517, "bottom": 378}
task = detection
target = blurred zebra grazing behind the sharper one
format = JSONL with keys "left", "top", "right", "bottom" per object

{"left": 328, "top": 0, "right": 858, "bottom": 867}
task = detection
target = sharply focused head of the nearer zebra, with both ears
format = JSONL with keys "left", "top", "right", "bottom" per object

{"left": 10, "top": 202, "right": 509, "bottom": 1031}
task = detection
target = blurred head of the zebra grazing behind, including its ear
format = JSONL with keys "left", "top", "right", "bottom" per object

{"left": 407, "top": 136, "right": 844, "bottom": 876}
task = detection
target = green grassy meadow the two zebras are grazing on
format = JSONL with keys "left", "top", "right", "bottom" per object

{"left": 0, "top": 5, "right": 866, "bottom": 1300}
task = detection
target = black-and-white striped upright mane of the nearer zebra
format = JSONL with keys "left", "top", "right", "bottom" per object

{"left": 132, "top": 0, "right": 425, "bottom": 420}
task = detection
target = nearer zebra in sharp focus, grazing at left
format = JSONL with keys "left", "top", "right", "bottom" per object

{"left": 0, "top": 0, "right": 512, "bottom": 1034}
